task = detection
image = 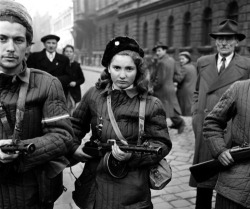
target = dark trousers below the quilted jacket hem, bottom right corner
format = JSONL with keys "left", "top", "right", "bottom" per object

{"left": 215, "top": 194, "right": 246, "bottom": 209}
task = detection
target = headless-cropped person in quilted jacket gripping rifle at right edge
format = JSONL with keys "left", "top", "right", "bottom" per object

{"left": 203, "top": 79, "right": 250, "bottom": 209}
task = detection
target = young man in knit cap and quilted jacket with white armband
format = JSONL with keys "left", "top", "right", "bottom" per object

{"left": 0, "top": 0, "right": 78, "bottom": 209}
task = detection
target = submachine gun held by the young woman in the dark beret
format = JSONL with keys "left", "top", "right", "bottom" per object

{"left": 82, "top": 139, "right": 162, "bottom": 157}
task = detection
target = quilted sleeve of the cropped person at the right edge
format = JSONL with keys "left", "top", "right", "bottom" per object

{"left": 203, "top": 83, "right": 237, "bottom": 158}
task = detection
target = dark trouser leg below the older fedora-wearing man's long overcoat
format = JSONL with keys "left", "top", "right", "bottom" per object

{"left": 195, "top": 187, "right": 213, "bottom": 209}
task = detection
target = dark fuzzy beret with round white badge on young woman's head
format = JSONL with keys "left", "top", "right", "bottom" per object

{"left": 102, "top": 36, "right": 144, "bottom": 67}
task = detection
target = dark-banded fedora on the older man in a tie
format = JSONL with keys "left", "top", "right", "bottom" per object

{"left": 209, "top": 19, "right": 246, "bottom": 41}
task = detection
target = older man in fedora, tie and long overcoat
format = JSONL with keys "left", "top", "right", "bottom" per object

{"left": 189, "top": 19, "right": 250, "bottom": 209}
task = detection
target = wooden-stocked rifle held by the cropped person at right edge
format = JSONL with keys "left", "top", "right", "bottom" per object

{"left": 189, "top": 143, "right": 250, "bottom": 183}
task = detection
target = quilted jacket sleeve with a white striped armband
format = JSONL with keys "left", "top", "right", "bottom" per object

{"left": 19, "top": 78, "right": 78, "bottom": 172}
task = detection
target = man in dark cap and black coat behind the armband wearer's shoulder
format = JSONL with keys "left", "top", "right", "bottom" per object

{"left": 27, "top": 34, "right": 71, "bottom": 95}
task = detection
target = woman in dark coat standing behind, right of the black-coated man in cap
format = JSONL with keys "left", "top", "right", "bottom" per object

{"left": 63, "top": 45, "right": 85, "bottom": 114}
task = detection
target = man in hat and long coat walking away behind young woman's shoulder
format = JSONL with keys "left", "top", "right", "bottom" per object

{"left": 151, "top": 43, "right": 185, "bottom": 134}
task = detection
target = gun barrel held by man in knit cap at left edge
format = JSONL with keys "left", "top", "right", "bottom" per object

{"left": 0, "top": 142, "right": 36, "bottom": 154}
